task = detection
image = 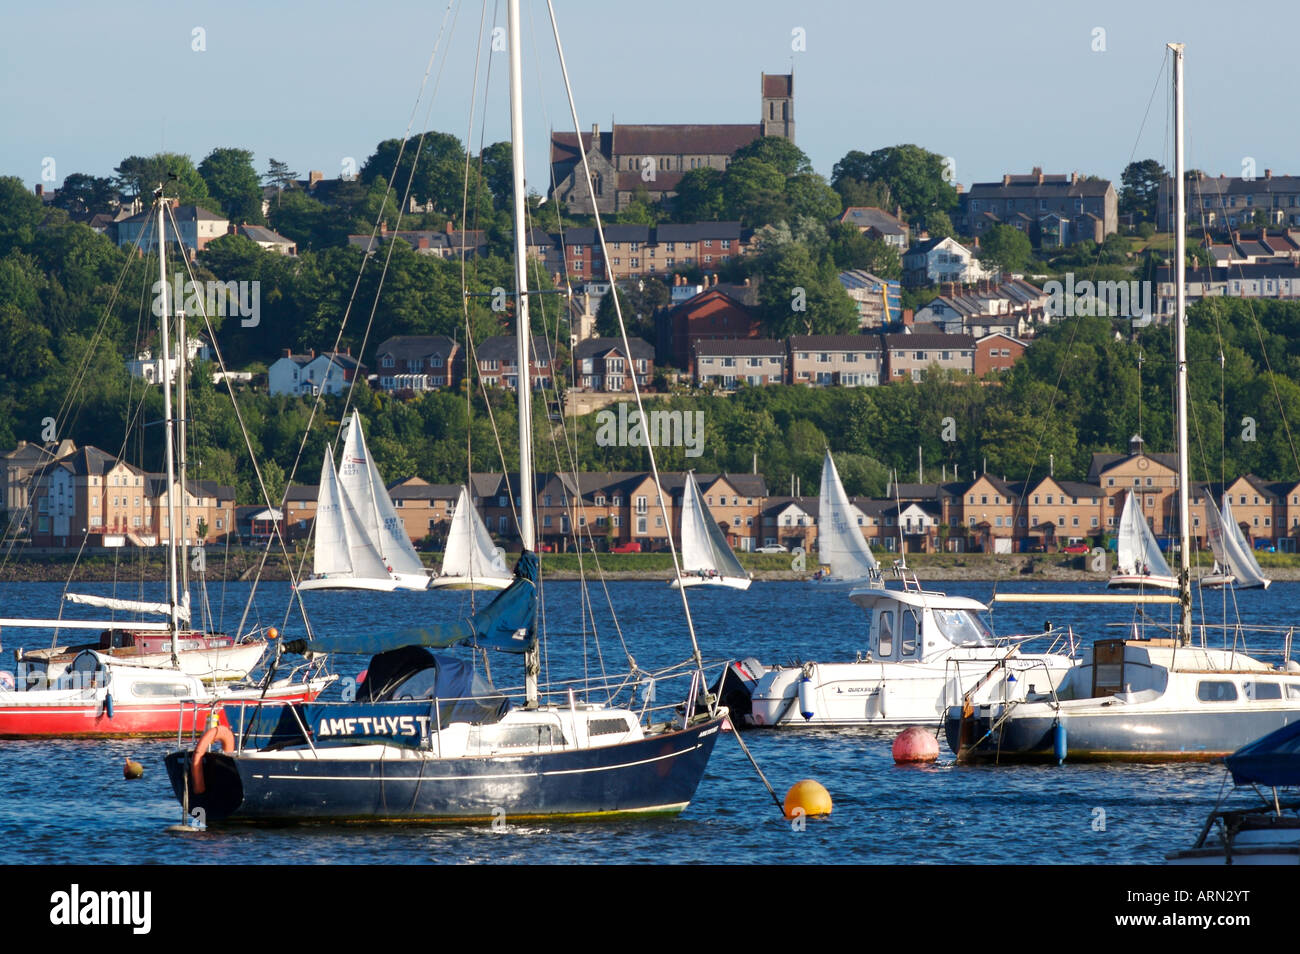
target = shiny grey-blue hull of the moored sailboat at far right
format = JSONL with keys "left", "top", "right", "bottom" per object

{"left": 944, "top": 706, "right": 1300, "bottom": 762}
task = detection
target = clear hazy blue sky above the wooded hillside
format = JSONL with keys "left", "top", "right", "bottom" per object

{"left": 0, "top": 0, "right": 1300, "bottom": 197}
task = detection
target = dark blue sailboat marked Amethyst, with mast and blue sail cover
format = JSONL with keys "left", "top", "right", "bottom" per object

{"left": 158, "top": 0, "right": 727, "bottom": 824}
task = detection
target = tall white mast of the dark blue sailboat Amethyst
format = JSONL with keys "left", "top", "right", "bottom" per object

{"left": 507, "top": 0, "right": 542, "bottom": 707}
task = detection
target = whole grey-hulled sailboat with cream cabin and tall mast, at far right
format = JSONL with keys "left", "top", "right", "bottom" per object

{"left": 944, "top": 43, "right": 1300, "bottom": 762}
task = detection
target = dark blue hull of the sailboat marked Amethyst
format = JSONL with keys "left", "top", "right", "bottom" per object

{"left": 166, "top": 716, "right": 723, "bottom": 824}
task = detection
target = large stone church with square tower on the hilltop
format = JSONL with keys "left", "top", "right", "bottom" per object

{"left": 549, "top": 73, "right": 794, "bottom": 214}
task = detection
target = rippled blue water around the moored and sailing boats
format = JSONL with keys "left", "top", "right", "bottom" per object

{"left": 0, "top": 582, "right": 1279, "bottom": 864}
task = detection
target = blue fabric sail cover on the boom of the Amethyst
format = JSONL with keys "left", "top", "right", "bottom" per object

{"left": 307, "top": 550, "right": 537, "bottom": 655}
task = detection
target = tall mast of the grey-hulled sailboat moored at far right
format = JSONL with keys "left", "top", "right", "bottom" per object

{"left": 1169, "top": 43, "right": 1192, "bottom": 646}
